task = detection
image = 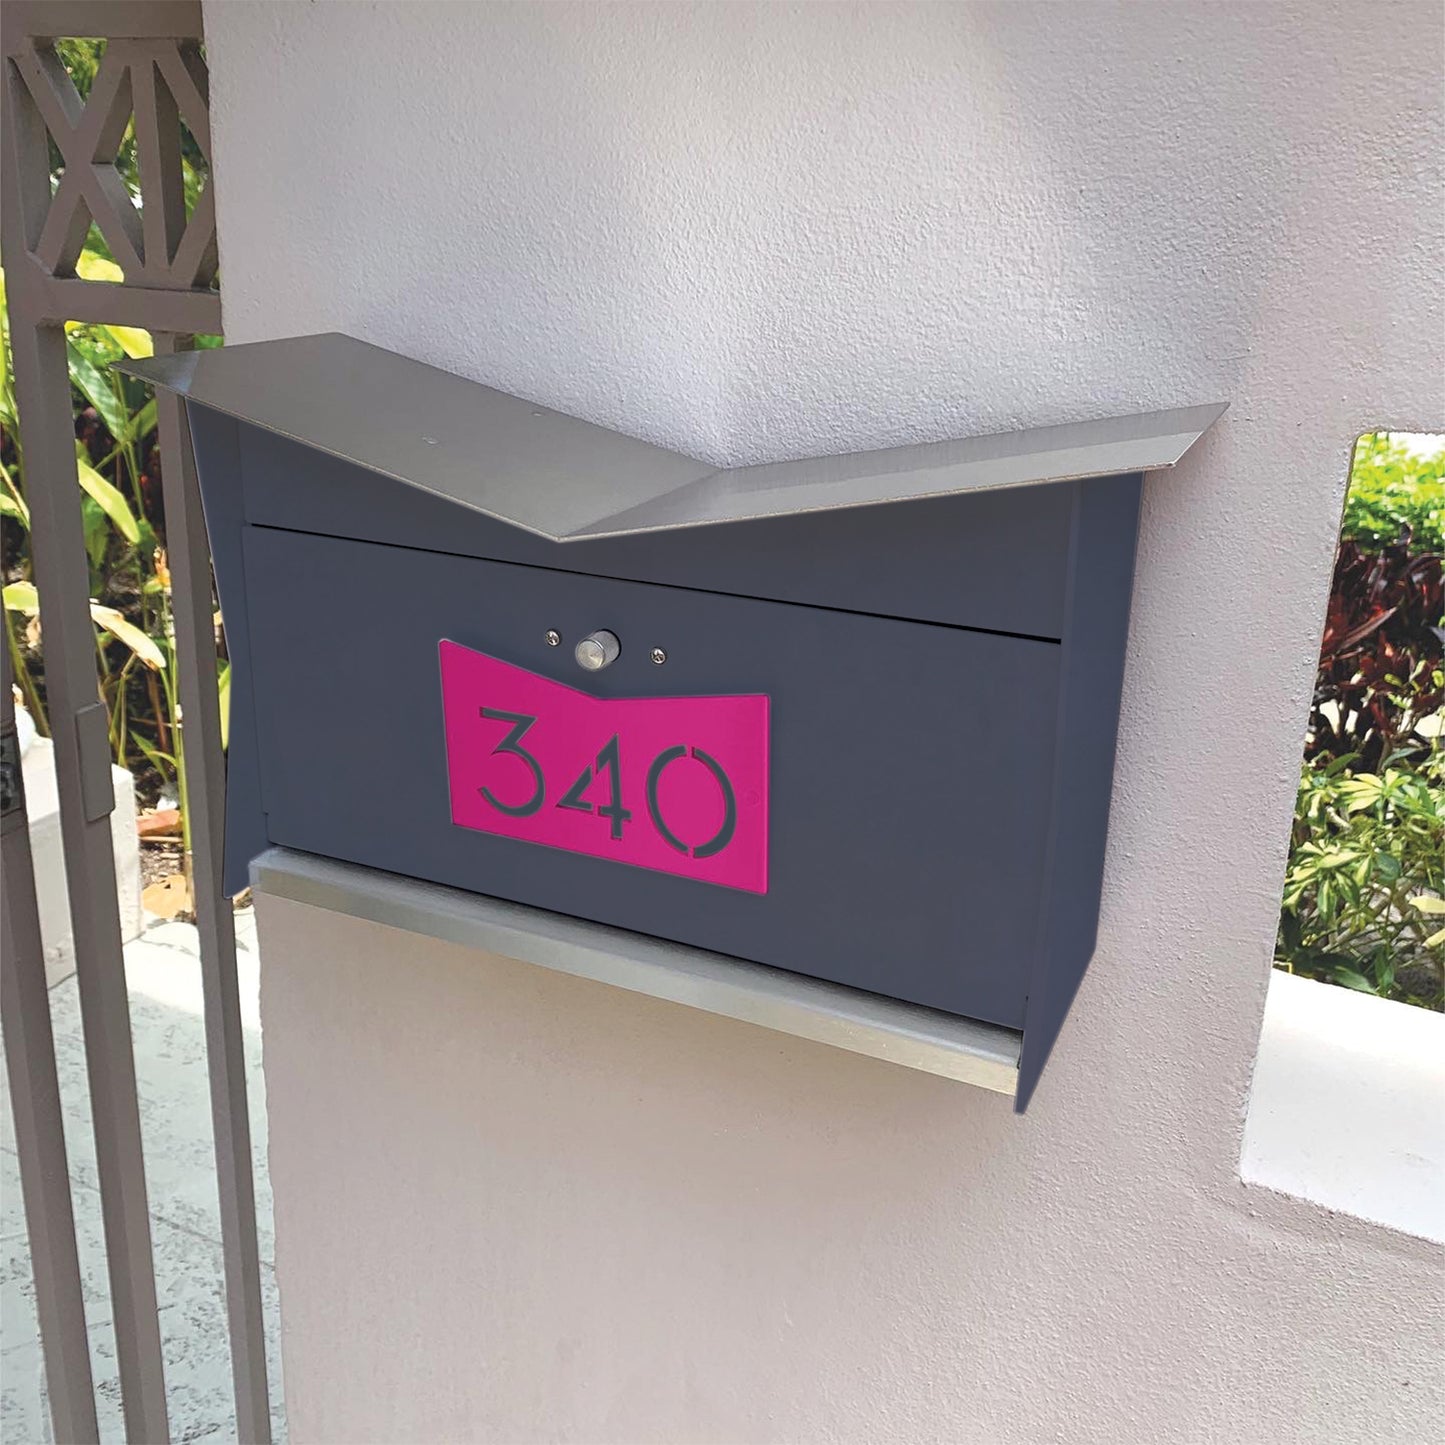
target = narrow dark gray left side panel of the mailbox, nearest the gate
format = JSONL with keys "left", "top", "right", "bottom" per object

{"left": 186, "top": 402, "right": 266, "bottom": 897}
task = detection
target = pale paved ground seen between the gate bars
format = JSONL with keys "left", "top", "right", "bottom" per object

{"left": 0, "top": 912, "right": 285, "bottom": 1445}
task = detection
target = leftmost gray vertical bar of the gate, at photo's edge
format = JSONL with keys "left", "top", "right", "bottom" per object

{"left": 0, "top": 649, "right": 100, "bottom": 1445}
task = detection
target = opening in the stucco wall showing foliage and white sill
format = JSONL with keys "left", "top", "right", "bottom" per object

{"left": 1240, "top": 432, "right": 1445, "bottom": 1243}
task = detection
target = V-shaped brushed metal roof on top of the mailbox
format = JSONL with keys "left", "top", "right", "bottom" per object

{"left": 121, "top": 332, "right": 1224, "bottom": 542}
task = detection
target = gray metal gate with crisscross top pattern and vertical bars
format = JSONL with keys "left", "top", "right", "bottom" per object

{"left": 0, "top": 0, "right": 270, "bottom": 1442}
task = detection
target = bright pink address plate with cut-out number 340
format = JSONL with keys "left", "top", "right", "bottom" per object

{"left": 439, "top": 642, "right": 767, "bottom": 893}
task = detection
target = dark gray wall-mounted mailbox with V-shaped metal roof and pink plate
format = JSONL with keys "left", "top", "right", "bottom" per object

{"left": 124, "top": 335, "right": 1224, "bottom": 1110}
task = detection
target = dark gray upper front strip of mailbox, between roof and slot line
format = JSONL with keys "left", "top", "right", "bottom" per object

{"left": 234, "top": 421, "right": 1074, "bottom": 639}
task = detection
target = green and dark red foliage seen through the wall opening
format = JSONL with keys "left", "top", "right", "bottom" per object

{"left": 1276, "top": 435, "right": 1445, "bottom": 1009}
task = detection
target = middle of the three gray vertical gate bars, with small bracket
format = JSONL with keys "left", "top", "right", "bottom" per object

{"left": 3, "top": 50, "right": 168, "bottom": 1442}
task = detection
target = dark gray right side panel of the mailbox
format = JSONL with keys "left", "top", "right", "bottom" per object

{"left": 1014, "top": 475, "right": 1144, "bottom": 1114}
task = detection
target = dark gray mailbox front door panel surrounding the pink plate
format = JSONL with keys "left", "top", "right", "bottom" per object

{"left": 246, "top": 527, "right": 1059, "bottom": 1027}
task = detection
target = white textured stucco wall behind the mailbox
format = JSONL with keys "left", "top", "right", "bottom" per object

{"left": 207, "top": 3, "right": 1445, "bottom": 1445}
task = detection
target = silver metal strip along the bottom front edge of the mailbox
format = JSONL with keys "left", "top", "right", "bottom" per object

{"left": 251, "top": 848, "right": 1020, "bottom": 1094}
